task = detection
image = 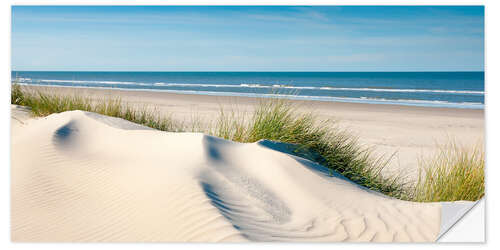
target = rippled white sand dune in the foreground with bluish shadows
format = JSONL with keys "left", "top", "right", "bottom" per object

{"left": 11, "top": 109, "right": 474, "bottom": 242}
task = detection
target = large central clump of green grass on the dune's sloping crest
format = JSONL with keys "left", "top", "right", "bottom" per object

{"left": 213, "top": 99, "right": 408, "bottom": 199}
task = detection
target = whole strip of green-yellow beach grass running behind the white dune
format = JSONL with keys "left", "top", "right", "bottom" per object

{"left": 11, "top": 84, "right": 484, "bottom": 201}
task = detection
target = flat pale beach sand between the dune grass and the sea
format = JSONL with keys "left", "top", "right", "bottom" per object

{"left": 20, "top": 86, "right": 485, "bottom": 180}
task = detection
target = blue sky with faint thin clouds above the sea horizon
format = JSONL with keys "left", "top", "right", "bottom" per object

{"left": 11, "top": 6, "right": 484, "bottom": 71}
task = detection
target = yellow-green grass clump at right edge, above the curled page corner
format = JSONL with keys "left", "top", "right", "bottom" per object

{"left": 413, "top": 143, "right": 484, "bottom": 202}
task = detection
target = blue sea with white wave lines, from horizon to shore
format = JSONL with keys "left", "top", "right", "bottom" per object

{"left": 12, "top": 71, "right": 485, "bottom": 109}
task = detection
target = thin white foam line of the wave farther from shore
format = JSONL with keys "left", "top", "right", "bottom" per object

{"left": 17, "top": 78, "right": 484, "bottom": 95}
